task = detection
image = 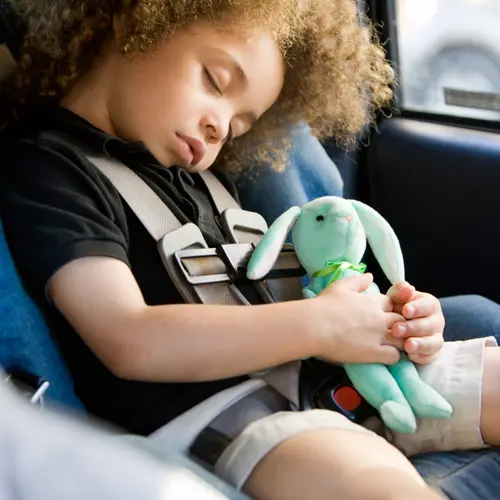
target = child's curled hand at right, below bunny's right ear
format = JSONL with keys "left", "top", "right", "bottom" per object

{"left": 387, "top": 282, "right": 445, "bottom": 364}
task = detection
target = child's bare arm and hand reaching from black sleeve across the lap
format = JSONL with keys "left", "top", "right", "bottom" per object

{"left": 48, "top": 257, "right": 401, "bottom": 381}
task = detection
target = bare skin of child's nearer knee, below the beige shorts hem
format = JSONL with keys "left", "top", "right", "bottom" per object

{"left": 244, "top": 429, "right": 441, "bottom": 500}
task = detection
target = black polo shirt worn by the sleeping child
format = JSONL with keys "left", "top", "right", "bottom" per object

{"left": 0, "top": 105, "right": 247, "bottom": 434}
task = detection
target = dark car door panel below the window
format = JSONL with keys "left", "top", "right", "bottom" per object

{"left": 364, "top": 118, "right": 500, "bottom": 302}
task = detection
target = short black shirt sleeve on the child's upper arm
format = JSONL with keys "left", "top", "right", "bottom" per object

{"left": 0, "top": 136, "right": 130, "bottom": 293}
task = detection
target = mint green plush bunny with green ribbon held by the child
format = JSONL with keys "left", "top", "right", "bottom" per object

{"left": 247, "top": 196, "right": 453, "bottom": 433}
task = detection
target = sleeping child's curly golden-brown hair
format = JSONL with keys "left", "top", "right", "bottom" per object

{"left": 2, "top": 0, "right": 394, "bottom": 170}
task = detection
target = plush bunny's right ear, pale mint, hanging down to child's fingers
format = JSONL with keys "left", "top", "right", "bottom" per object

{"left": 349, "top": 200, "right": 405, "bottom": 284}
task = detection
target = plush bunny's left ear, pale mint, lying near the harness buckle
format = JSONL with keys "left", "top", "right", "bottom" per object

{"left": 247, "top": 207, "right": 302, "bottom": 280}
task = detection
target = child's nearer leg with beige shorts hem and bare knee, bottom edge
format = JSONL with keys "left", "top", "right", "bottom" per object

{"left": 215, "top": 408, "right": 438, "bottom": 500}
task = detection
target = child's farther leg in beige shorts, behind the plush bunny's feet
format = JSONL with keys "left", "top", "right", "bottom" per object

{"left": 385, "top": 337, "right": 500, "bottom": 456}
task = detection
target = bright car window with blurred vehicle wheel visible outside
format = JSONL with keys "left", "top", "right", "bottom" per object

{"left": 395, "top": 0, "right": 500, "bottom": 120}
